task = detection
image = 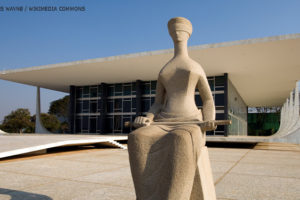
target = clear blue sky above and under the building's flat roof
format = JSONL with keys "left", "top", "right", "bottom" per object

{"left": 0, "top": 0, "right": 300, "bottom": 122}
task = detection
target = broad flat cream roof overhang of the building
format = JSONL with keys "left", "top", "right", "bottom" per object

{"left": 0, "top": 34, "right": 300, "bottom": 106}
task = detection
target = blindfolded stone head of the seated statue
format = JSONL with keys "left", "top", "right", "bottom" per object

{"left": 168, "top": 17, "right": 193, "bottom": 42}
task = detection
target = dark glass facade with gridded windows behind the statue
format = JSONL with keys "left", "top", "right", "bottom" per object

{"left": 70, "top": 76, "right": 227, "bottom": 135}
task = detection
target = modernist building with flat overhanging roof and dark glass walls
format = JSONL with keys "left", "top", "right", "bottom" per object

{"left": 0, "top": 34, "right": 300, "bottom": 136}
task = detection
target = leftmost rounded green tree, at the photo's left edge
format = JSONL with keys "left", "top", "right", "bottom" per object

{"left": 2, "top": 108, "right": 32, "bottom": 133}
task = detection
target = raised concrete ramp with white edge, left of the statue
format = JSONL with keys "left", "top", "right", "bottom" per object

{"left": 0, "top": 134, "right": 128, "bottom": 159}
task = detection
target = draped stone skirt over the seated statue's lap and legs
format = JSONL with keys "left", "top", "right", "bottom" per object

{"left": 128, "top": 112, "right": 204, "bottom": 200}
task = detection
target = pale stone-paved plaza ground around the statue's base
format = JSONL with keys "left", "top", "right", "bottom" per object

{"left": 0, "top": 145, "right": 300, "bottom": 200}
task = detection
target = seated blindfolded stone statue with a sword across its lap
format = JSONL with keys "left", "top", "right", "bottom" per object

{"left": 128, "top": 17, "right": 216, "bottom": 200}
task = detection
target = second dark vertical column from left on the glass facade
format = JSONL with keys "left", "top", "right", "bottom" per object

{"left": 97, "top": 83, "right": 108, "bottom": 134}
